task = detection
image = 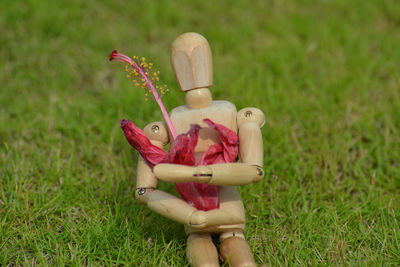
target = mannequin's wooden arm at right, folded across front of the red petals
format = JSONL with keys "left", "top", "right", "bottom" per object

{"left": 153, "top": 108, "right": 265, "bottom": 186}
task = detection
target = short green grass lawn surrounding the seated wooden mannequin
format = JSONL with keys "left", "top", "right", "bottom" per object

{"left": 0, "top": 0, "right": 400, "bottom": 266}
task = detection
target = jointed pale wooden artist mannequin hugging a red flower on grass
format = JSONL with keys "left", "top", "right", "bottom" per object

{"left": 136, "top": 33, "right": 265, "bottom": 266}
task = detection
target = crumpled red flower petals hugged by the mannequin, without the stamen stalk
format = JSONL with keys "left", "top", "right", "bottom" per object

{"left": 121, "top": 119, "right": 239, "bottom": 211}
